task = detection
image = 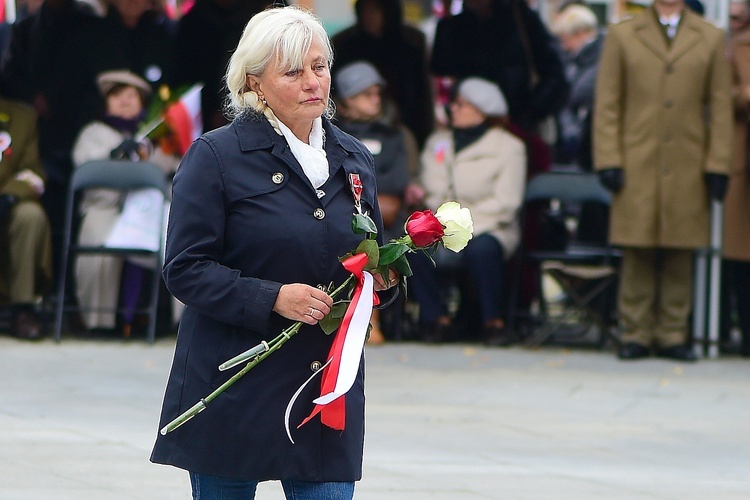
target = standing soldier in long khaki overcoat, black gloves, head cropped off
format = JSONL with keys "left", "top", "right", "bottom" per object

{"left": 594, "top": 0, "right": 732, "bottom": 361}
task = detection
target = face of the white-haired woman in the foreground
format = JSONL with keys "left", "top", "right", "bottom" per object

{"left": 247, "top": 41, "right": 331, "bottom": 142}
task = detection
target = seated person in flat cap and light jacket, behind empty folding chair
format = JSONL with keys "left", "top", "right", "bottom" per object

{"left": 73, "top": 70, "right": 179, "bottom": 336}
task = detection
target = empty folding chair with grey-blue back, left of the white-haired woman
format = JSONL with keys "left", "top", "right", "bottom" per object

{"left": 55, "top": 160, "right": 170, "bottom": 343}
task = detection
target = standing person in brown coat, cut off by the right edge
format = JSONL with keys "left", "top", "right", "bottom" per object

{"left": 722, "top": 0, "right": 750, "bottom": 356}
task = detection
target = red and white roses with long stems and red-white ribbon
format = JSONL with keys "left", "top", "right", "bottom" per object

{"left": 160, "top": 201, "right": 474, "bottom": 442}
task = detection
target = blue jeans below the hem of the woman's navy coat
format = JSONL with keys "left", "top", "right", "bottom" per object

{"left": 190, "top": 472, "right": 354, "bottom": 500}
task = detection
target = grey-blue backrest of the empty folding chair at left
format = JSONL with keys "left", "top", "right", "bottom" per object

{"left": 71, "top": 160, "right": 169, "bottom": 198}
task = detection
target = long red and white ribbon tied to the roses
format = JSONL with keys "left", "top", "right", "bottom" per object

{"left": 284, "top": 254, "right": 377, "bottom": 443}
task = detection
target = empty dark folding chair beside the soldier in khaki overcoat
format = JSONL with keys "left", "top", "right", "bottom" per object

{"left": 517, "top": 171, "right": 620, "bottom": 346}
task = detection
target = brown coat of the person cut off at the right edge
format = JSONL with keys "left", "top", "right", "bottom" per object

{"left": 724, "top": 28, "right": 750, "bottom": 261}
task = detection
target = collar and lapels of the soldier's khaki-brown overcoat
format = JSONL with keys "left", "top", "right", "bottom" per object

{"left": 633, "top": 8, "right": 704, "bottom": 63}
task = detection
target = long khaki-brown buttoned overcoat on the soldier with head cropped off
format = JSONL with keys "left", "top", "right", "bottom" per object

{"left": 594, "top": 9, "right": 732, "bottom": 248}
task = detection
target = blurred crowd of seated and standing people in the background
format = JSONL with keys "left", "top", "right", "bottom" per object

{"left": 0, "top": 0, "right": 750, "bottom": 361}
